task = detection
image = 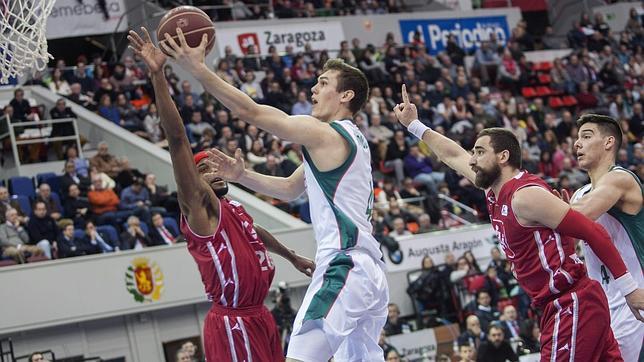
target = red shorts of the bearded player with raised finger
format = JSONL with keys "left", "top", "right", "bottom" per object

{"left": 541, "top": 278, "right": 623, "bottom": 362}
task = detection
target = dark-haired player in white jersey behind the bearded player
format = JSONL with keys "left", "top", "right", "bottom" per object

{"left": 564, "top": 114, "right": 644, "bottom": 362}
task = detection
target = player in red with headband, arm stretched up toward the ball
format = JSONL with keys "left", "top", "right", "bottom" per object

{"left": 128, "top": 28, "right": 315, "bottom": 361}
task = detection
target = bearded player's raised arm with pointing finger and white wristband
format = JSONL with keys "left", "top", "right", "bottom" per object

{"left": 394, "top": 84, "right": 476, "bottom": 184}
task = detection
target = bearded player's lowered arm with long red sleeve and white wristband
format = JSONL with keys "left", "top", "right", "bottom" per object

{"left": 512, "top": 187, "right": 644, "bottom": 322}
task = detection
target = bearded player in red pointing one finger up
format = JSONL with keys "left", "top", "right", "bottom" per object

{"left": 394, "top": 85, "right": 644, "bottom": 362}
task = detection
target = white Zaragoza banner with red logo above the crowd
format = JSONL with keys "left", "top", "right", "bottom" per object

{"left": 217, "top": 21, "right": 344, "bottom": 55}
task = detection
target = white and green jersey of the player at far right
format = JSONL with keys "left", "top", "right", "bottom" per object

{"left": 571, "top": 166, "right": 644, "bottom": 309}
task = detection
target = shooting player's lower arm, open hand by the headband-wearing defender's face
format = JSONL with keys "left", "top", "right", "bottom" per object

{"left": 205, "top": 148, "right": 305, "bottom": 201}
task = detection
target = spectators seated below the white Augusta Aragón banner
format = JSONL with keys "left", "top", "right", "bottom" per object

{"left": 379, "top": 247, "right": 540, "bottom": 361}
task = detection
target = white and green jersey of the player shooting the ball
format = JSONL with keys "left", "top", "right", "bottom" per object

{"left": 302, "top": 119, "right": 382, "bottom": 260}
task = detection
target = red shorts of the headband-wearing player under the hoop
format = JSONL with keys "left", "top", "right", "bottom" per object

{"left": 203, "top": 304, "right": 284, "bottom": 362}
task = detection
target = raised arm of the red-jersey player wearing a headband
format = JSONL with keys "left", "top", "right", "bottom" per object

{"left": 128, "top": 28, "right": 219, "bottom": 235}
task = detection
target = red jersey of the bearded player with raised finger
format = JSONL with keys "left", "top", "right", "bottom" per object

{"left": 487, "top": 171, "right": 586, "bottom": 307}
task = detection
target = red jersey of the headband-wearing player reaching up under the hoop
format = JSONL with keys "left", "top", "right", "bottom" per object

{"left": 181, "top": 198, "right": 275, "bottom": 308}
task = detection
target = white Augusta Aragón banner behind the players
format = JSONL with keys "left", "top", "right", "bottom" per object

{"left": 384, "top": 224, "right": 497, "bottom": 272}
